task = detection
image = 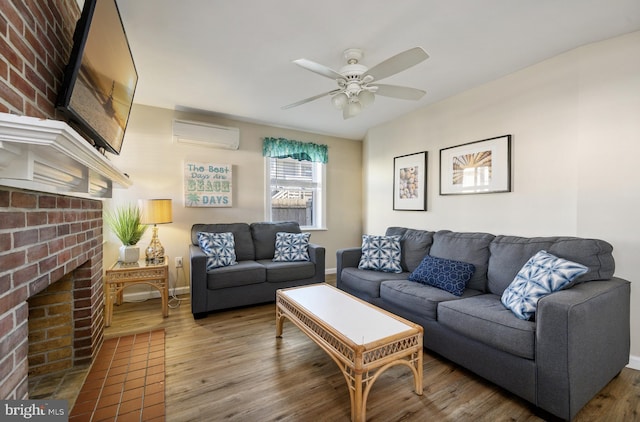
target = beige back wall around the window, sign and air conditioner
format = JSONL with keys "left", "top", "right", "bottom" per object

{"left": 104, "top": 105, "right": 362, "bottom": 291}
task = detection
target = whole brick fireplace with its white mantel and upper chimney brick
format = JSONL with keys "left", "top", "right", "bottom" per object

{"left": 0, "top": 0, "right": 131, "bottom": 400}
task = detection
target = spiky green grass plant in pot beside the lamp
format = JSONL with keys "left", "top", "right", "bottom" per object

{"left": 105, "top": 205, "right": 148, "bottom": 262}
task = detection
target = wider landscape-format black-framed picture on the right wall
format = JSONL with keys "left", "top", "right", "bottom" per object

{"left": 440, "top": 135, "right": 511, "bottom": 195}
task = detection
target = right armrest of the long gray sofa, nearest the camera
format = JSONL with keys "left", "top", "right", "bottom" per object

{"left": 536, "top": 278, "right": 631, "bottom": 420}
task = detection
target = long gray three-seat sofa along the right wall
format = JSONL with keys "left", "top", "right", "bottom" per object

{"left": 337, "top": 227, "right": 631, "bottom": 420}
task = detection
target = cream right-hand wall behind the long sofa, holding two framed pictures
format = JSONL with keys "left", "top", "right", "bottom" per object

{"left": 364, "top": 32, "right": 640, "bottom": 369}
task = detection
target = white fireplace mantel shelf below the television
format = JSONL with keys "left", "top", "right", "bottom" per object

{"left": 0, "top": 113, "right": 132, "bottom": 199}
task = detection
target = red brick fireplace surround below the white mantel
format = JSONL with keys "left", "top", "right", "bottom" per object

{"left": 0, "top": 187, "right": 104, "bottom": 400}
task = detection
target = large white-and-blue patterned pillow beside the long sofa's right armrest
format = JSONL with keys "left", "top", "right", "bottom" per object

{"left": 501, "top": 251, "right": 588, "bottom": 320}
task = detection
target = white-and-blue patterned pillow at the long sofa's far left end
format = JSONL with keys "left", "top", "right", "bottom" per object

{"left": 358, "top": 234, "right": 402, "bottom": 273}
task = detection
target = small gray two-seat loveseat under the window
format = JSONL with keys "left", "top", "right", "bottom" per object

{"left": 189, "top": 222, "right": 325, "bottom": 319}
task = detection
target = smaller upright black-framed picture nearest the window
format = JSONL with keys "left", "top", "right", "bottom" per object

{"left": 393, "top": 151, "right": 427, "bottom": 211}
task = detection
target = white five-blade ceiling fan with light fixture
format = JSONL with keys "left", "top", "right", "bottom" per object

{"left": 282, "top": 47, "right": 429, "bottom": 119}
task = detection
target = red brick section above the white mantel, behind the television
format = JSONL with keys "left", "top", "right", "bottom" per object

{"left": 0, "top": 0, "right": 80, "bottom": 119}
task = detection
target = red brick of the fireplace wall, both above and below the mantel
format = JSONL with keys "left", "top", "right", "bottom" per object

{"left": 0, "top": 0, "right": 99, "bottom": 399}
